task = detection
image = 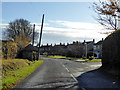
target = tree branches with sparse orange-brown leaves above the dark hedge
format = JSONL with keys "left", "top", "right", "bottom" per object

{"left": 93, "top": 0, "right": 120, "bottom": 30}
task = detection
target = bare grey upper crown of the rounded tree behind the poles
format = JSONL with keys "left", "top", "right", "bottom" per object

{"left": 7, "top": 19, "right": 32, "bottom": 40}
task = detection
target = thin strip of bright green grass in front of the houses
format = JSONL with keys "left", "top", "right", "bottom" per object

{"left": 44, "top": 55, "right": 101, "bottom": 62}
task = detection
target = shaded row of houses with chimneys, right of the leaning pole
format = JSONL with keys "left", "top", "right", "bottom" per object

{"left": 40, "top": 39, "right": 103, "bottom": 58}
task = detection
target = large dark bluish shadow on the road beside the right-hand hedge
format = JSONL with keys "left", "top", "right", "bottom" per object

{"left": 77, "top": 69, "right": 120, "bottom": 89}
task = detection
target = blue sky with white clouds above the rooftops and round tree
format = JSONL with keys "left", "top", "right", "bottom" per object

{"left": 2, "top": 2, "right": 112, "bottom": 45}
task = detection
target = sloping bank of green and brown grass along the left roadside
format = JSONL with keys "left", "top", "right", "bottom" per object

{"left": 2, "top": 59, "right": 43, "bottom": 89}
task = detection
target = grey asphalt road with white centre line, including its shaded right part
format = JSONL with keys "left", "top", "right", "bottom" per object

{"left": 15, "top": 58, "right": 120, "bottom": 90}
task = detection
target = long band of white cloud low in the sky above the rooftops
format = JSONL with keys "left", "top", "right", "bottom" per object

{"left": 1, "top": 20, "right": 112, "bottom": 43}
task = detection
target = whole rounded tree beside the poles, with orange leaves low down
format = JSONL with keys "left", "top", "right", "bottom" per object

{"left": 7, "top": 19, "right": 38, "bottom": 49}
